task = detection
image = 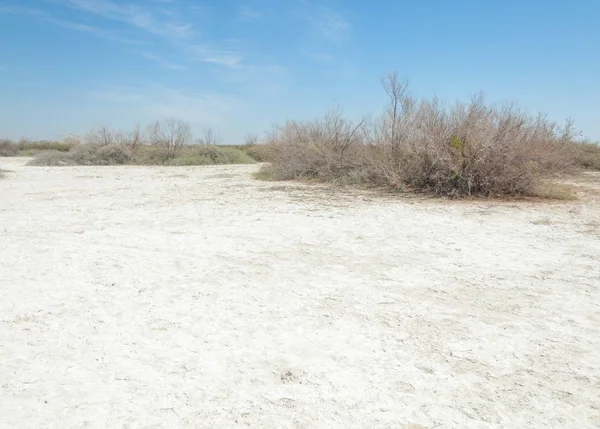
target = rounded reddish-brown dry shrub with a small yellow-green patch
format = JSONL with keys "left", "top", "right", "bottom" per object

{"left": 370, "top": 96, "right": 572, "bottom": 196}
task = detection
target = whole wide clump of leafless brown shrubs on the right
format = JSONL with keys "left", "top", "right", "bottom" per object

{"left": 261, "top": 75, "right": 588, "bottom": 197}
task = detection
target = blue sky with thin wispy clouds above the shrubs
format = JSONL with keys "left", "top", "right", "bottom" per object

{"left": 0, "top": 0, "right": 600, "bottom": 143}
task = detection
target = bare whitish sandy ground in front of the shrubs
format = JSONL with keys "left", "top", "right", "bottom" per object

{"left": 0, "top": 158, "right": 600, "bottom": 429}
